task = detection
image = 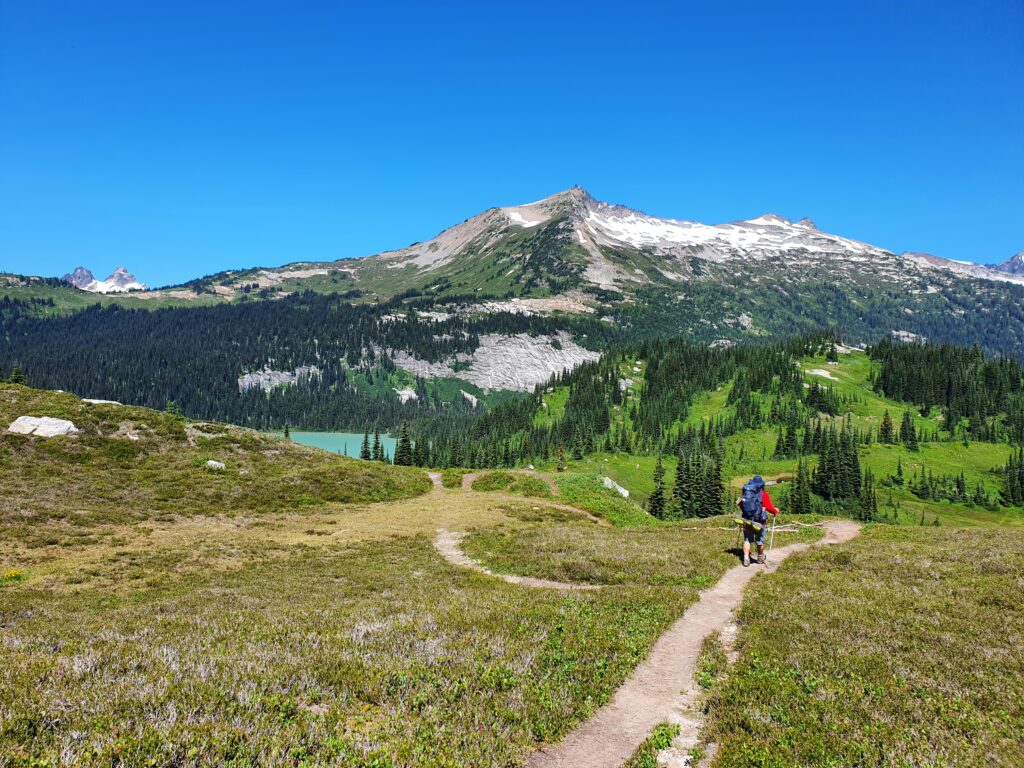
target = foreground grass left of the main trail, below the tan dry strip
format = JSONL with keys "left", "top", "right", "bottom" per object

{"left": 0, "top": 537, "right": 688, "bottom": 768}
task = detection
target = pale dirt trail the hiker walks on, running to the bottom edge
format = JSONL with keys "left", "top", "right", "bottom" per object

{"left": 526, "top": 520, "right": 860, "bottom": 768}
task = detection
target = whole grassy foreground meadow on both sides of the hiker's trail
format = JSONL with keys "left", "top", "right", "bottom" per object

{"left": 0, "top": 385, "right": 1024, "bottom": 768}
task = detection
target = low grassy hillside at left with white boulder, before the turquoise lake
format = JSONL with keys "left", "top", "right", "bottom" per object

{"left": 0, "top": 384, "right": 430, "bottom": 541}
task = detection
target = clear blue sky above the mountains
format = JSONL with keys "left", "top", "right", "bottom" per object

{"left": 0, "top": 0, "right": 1024, "bottom": 285}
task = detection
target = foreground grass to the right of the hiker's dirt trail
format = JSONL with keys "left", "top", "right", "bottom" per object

{"left": 703, "top": 526, "right": 1024, "bottom": 768}
